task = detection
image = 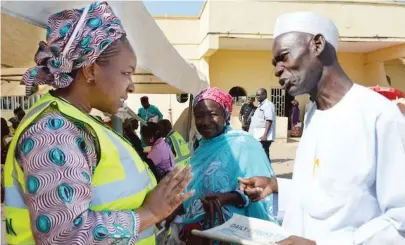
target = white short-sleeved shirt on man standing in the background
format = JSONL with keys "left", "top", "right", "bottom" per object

{"left": 249, "top": 99, "right": 276, "bottom": 141}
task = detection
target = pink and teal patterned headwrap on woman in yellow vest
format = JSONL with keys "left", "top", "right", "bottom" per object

{"left": 22, "top": 2, "right": 125, "bottom": 95}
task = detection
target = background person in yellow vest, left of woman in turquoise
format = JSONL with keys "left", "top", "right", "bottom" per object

{"left": 158, "top": 119, "right": 191, "bottom": 167}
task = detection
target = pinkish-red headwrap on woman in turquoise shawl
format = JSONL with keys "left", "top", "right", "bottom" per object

{"left": 193, "top": 88, "right": 232, "bottom": 124}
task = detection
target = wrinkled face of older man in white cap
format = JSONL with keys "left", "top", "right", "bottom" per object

{"left": 272, "top": 32, "right": 322, "bottom": 96}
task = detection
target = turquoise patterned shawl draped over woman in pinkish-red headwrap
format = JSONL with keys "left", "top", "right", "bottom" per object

{"left": 183, "top": 126, "right": 277, "bottom": 224}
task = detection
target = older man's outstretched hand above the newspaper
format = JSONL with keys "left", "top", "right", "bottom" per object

{"left": 239, "top": 176, "right": 278, "bottom": 202}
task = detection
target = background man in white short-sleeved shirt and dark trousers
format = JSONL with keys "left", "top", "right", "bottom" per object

{"left": 249, "top": 88, "right": 276, "bottom": 159}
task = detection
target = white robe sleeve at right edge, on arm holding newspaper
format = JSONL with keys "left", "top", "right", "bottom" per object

{"left": 316, "top": 108, "right": 405, "bottom": 245}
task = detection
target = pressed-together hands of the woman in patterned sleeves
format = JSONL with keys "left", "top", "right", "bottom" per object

{"left": 138, "top": 167, "right": 194, "bottom": 231}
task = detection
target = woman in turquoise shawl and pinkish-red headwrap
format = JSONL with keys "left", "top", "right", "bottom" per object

{"left": 167, "top": 88, "right": 275, "bottom": 244}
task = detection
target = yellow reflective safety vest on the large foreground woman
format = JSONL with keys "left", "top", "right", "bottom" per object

{"left": 4, "top": 93, "right": 156, "bottom": 245}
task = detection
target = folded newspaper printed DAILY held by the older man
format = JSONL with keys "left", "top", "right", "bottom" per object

{"left": 192, "top": 214, "right": 290, "bottom": 245}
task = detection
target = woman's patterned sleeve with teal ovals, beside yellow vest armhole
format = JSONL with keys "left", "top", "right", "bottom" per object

{"left": 16, "top": 113, "right": 140, "bottom": 245}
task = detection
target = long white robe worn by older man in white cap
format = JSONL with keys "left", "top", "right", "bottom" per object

{"left": 279, "top": 85, "right": 405, "bottom": 245}
